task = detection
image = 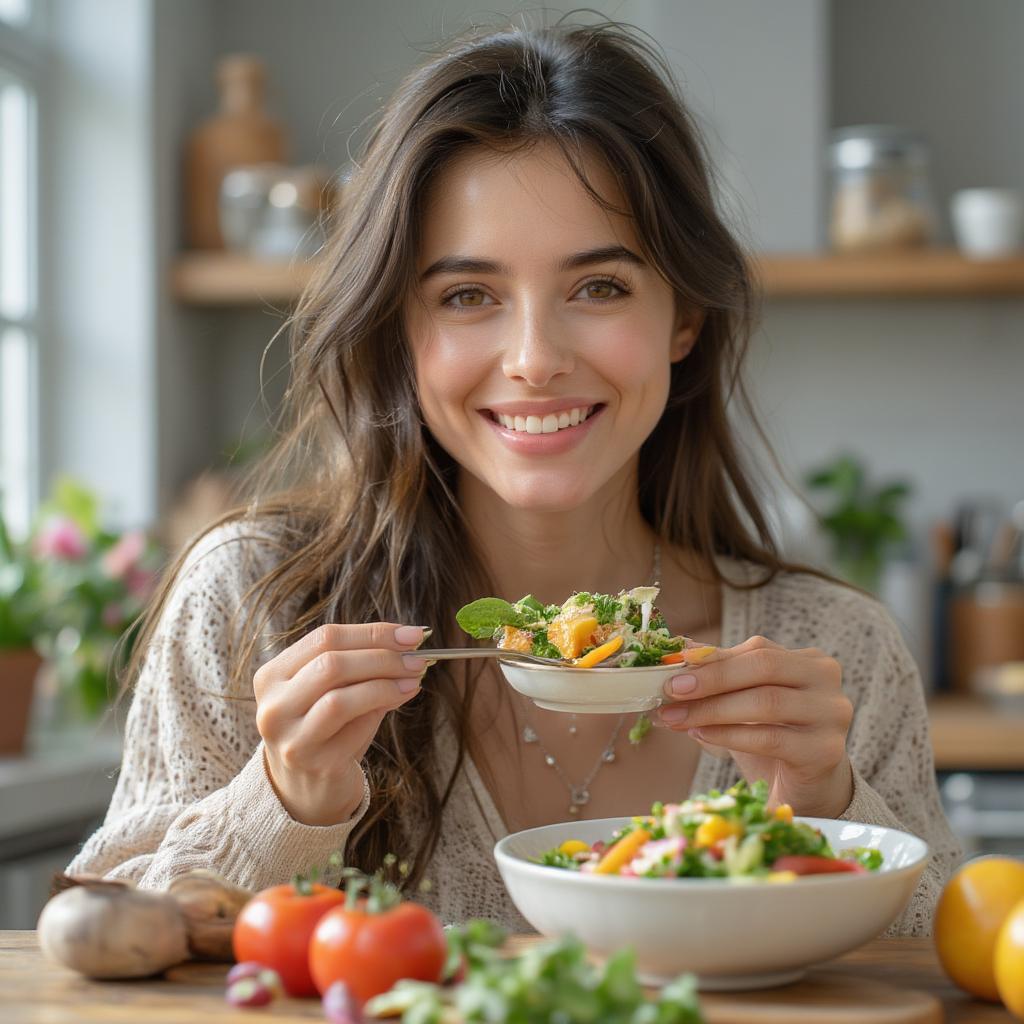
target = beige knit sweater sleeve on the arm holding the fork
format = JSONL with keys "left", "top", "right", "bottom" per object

{"left": 68, "top": 525, "right": 370, "bottom": 890}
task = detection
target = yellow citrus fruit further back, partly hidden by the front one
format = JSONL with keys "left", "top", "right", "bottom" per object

{"left": 935, "top": 857, "right": 1024, "bottom": 1002}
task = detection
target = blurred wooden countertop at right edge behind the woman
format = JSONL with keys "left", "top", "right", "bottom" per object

{"left": 929, "top": 694, "right": 1024, "bottom": 771}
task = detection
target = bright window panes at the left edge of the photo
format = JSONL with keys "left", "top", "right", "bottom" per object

{"left": 0, "top": 0, "right": 39, "bottom": 535}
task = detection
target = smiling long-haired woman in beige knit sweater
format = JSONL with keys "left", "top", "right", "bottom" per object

{"left": 72, "top": 18, "right": 956, "bottom": 933}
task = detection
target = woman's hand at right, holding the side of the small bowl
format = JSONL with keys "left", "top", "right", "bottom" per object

{"left": 657, "top": 637, "right": 853, "bottom": 818}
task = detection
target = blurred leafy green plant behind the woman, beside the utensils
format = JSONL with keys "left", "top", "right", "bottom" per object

{"left": 804, "top": 455, "right": 911, "bottom": 594}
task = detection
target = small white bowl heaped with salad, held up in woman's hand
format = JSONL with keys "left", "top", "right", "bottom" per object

{"left": 456, "top": 587, "right": 717, "bottom": 714}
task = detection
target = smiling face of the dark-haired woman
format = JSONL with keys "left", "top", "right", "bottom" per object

{"left": 406, "top": 146, "right": 700, "bottom": 511}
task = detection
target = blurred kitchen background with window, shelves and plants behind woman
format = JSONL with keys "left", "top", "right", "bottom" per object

{"left": 0, "top": 0, "right": 1024, "bottom": 928}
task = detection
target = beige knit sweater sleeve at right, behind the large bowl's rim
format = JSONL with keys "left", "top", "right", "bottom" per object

{"left": 841, "top": 606, "right": 962, "bottom": 935}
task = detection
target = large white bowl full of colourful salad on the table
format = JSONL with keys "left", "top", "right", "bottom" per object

{"left": 495, "top": 782, "right": 929, "bottom": 990}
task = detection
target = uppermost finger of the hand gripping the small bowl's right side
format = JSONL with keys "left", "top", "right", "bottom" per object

{"left": 665, "top": 637, "right": 842, "bottom": 700}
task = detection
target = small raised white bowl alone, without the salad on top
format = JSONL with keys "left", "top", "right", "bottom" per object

{"left": 498, "top": 659, "right": 687, "bottom": 715}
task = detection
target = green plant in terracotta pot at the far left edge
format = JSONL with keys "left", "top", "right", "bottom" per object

{"left": 0, "top": 501, "right": 43, "bottom": 756}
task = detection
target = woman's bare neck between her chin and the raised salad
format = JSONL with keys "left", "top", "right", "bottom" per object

{"left": 459, "top": 467, "right": 655, "bottom": 604}
